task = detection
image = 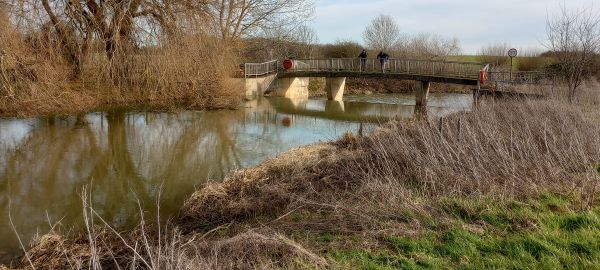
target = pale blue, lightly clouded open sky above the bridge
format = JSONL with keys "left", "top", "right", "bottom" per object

{"left": 310, "top": 0, "right": 600, "bottom": 54}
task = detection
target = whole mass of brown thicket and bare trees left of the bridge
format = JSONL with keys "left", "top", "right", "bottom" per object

{"left": 0, "top": 0, "right": 313, "bottom": 116}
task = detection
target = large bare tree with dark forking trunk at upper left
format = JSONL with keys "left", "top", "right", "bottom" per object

{"left": 7, "top": 0, "right": 183, "bottom": 76}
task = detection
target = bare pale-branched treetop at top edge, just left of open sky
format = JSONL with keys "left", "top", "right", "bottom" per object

{"left": 200, "top": 0, "right": 314, "bottom": 41}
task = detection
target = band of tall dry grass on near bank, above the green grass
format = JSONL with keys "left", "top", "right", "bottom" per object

{"left": 182, "top": 98, "right": 600, "bottom": 229}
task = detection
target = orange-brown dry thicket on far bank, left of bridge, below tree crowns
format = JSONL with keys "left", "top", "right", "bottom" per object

{"left": 0, "top": 8, "right": 243, "bottom": 116}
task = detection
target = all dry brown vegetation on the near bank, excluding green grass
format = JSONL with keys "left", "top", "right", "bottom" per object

{"left": 5, "top": 96, "right": 600, "bottom": 269}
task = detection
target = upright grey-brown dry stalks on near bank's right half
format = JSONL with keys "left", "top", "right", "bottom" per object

{"left": 357, "top": 102, "right": 600, "bottom": 201}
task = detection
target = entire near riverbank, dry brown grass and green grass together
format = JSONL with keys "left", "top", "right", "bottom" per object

{"left": 4, "top": 98, "right": 600, "bottom": 269}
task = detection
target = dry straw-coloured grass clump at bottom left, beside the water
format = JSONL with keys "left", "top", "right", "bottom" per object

{"left": 9, "top": 187, "right": 326, "bottom": 270}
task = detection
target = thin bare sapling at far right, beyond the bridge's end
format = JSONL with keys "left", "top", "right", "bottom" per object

{"left": 545, "top": 6, "right": 600, "bottom": 102}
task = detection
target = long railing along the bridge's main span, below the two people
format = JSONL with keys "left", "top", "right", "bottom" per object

{"left": 293, "top": 58, "right": 485, "bottom": 79}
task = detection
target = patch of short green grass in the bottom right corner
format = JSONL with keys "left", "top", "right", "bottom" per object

{"left": 331, "top": 194, "right": 600, "bottom": 269}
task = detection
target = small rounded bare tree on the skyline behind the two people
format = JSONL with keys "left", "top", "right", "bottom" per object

{"left": 363, "top": 14, "right": 401, "bottom": 51}
